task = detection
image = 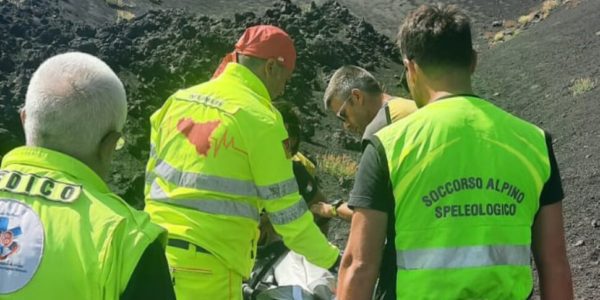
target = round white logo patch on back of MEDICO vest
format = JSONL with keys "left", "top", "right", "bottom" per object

{"left": 0, "top": 199, "right": 44, "bottom": 295}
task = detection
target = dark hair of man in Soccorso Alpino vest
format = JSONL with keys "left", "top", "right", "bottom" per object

{"left": 398, "top": 4, "right": 474, "bottom": 71}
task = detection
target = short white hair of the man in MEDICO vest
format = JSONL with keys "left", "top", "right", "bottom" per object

{"left": 24, "top": 52, "right": 127, "bottom": 157}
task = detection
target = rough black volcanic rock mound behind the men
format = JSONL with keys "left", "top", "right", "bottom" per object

{"left": 0, "top": 0, "right": 400, "bottom": 206}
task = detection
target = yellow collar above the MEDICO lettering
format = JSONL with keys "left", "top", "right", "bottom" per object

{"left": 1, "top": 146, "right": 110, "bottom": 193}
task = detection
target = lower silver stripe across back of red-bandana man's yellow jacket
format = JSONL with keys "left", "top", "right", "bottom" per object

{"left": 150, "top": 181, "right": 260, "bottom": 222}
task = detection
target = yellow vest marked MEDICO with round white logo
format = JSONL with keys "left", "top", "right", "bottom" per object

{"left": 0, "top": 147, "right": 166, "bottom": 299}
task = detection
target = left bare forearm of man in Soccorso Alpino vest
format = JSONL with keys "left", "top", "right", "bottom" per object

{"left": 337, "top": 208, "right": 388, "bottom": 300}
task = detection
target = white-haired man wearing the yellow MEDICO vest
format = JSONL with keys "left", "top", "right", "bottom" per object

{"left": 0, "top": 53, "right": 174, "bottom": 299}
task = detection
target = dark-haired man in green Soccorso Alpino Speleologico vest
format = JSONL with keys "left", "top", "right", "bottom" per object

{"left": 338, "top": 6, "right": 573, "bottom": 300}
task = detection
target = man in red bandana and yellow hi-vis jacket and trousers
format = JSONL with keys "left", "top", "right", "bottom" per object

{"left": 146, "top": 25, "right": 339, "bottom": 299}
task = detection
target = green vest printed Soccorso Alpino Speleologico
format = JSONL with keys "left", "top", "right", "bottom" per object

{"left": 374, "top": 96, "right": 550, "bottom": 299}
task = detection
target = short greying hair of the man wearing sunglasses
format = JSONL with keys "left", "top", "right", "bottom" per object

{"left": 323, "top": 65, "right": 383, "bottom": 108}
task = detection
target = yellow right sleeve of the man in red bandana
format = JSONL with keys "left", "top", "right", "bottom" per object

{"left": 244, "top": 124, "right": 340, "bottom": 268}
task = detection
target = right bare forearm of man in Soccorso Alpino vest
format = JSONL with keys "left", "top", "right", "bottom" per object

{"left": 532, "top": 202, "right": 573, "bottom": 300}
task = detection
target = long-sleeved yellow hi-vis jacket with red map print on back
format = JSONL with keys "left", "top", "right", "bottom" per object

{"left": 145, "top": 63, "right": 339, "bottom": 277}
